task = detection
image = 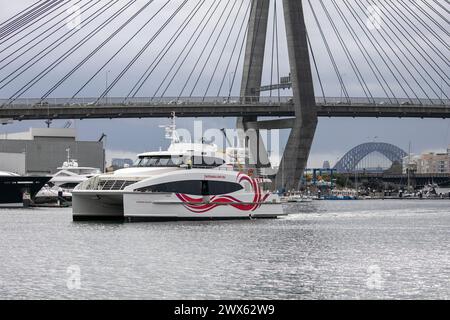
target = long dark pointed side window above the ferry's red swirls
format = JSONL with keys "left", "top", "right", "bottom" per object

{"left": 137, "top": 180, "right": 243, "bottom": 196}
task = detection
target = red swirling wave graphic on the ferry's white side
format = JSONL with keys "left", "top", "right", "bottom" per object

{"left": 176, "top": 172, "right": 270, "bottom": 213}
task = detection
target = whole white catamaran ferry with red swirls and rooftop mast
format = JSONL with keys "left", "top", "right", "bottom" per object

{"left": 72, "top": 117, "right": 284, "bottom": 221}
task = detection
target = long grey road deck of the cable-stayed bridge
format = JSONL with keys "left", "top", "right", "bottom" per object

{"left": 0, "top": 97, "right": 450, "bottom": 120}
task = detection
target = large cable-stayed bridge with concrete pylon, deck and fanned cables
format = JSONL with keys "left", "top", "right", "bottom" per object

{"left": 0, "top": 0, "right": 450, "bottom": 188}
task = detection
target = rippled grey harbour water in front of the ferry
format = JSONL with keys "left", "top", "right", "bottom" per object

{"left": 0, "top": 200, "right": 450, "bottom": 299}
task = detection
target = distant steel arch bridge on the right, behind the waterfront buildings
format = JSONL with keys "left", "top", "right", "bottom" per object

{"left": 334, "top": 142, "right": 408, "bottom": 173}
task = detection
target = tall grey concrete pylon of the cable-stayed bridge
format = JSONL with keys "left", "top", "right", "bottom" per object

{"left": 237, "top": 0, "right": 317, "bottom": 189}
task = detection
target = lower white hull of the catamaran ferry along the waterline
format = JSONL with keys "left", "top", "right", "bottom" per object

{"left": 72, "top": 191, "right": 285, "bottom": 221}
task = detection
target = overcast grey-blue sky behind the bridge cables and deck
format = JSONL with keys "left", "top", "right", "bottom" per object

{"left": 0, "top": 0, "right": 450, "bottom": 166}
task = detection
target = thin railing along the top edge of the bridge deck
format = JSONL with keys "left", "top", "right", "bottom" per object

{"left": 0, "top": 96, "right": 450, "bottom": 107}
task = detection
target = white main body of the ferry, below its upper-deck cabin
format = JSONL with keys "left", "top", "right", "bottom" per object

{"left": 72, "top": 170, "right": 284, "bottom": 220}
